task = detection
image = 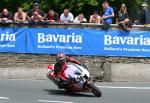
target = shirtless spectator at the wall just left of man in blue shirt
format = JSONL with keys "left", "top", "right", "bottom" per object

{"left": 89, "top": 11, "right": 101, "bottom": 23}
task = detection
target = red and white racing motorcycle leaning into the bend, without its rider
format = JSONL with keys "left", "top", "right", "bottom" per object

{"left": 47, "top": 64, "right": 102, "bottom": 97}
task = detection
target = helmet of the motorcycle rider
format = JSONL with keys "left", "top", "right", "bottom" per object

{"left": 56, "top": 52, "right": 66, "bottom": 65}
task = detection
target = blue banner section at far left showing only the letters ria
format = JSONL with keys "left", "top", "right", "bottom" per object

{"left": 0, "top": 28, "right": 27, "bottom": 53}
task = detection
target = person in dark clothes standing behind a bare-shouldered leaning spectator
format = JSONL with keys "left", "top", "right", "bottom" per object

{"left": 27, "top": 3, "right": 45, "bottom": 19}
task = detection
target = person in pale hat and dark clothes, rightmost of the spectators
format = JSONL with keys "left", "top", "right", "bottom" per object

{"left": 140, "top": 3, "right": 150, "bottom": 25}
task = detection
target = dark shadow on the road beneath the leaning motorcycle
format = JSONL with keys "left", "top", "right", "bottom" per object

{"left": 44, "top": 89, "right": 95, "bottom": 97}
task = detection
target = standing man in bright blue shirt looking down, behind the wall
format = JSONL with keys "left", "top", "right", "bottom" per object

{"left": 102, "top": 1, "right": 115, "bottom": 24}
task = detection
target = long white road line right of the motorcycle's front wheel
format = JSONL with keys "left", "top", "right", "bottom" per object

{"left": 97, "top": 86, "right": 150, "bottom": 90}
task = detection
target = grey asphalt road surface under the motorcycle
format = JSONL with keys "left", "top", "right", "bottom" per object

{"left": 0, "top": 80, "right": 150, "bottom": 103}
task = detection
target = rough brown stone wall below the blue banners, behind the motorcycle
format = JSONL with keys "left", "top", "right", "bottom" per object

{"left": 0, "top": 53, "right": 150, "bottom": 80}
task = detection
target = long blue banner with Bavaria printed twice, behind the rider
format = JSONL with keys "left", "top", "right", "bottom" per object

{"left": 27, "top": 28, "right": 150, "bottom": 57}
